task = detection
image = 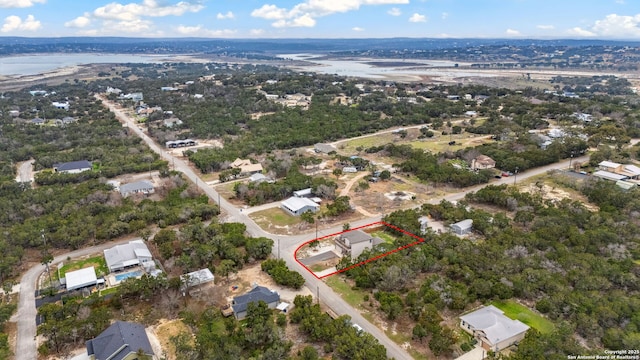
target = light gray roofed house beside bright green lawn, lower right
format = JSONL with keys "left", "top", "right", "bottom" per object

{"left": 460, "top": 305, "right": 529, "bottom": 352}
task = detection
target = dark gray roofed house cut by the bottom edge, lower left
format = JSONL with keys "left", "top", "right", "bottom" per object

{"left": 86, "top": 321, "right": 154, "bottom": 360}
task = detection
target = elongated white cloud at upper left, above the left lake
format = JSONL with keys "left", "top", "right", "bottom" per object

{"left": 93, "top": 0, "right": 204, "bottom": 21}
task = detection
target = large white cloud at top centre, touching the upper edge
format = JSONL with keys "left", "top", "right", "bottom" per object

{"left": 251, "top": 0, "right": 409, "bottom": 28}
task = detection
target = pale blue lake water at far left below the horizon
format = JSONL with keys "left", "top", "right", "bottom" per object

{"left": 0, "top": 54, "right": 167, "bottom": 75}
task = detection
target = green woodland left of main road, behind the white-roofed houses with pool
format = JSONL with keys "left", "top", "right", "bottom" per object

{"left": 0, "top": 175, "right": 219, "bottom": 282}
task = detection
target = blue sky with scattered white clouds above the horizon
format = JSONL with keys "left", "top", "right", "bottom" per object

{"left": 0, "top": 0, "right": 640, "bottom": 40}
